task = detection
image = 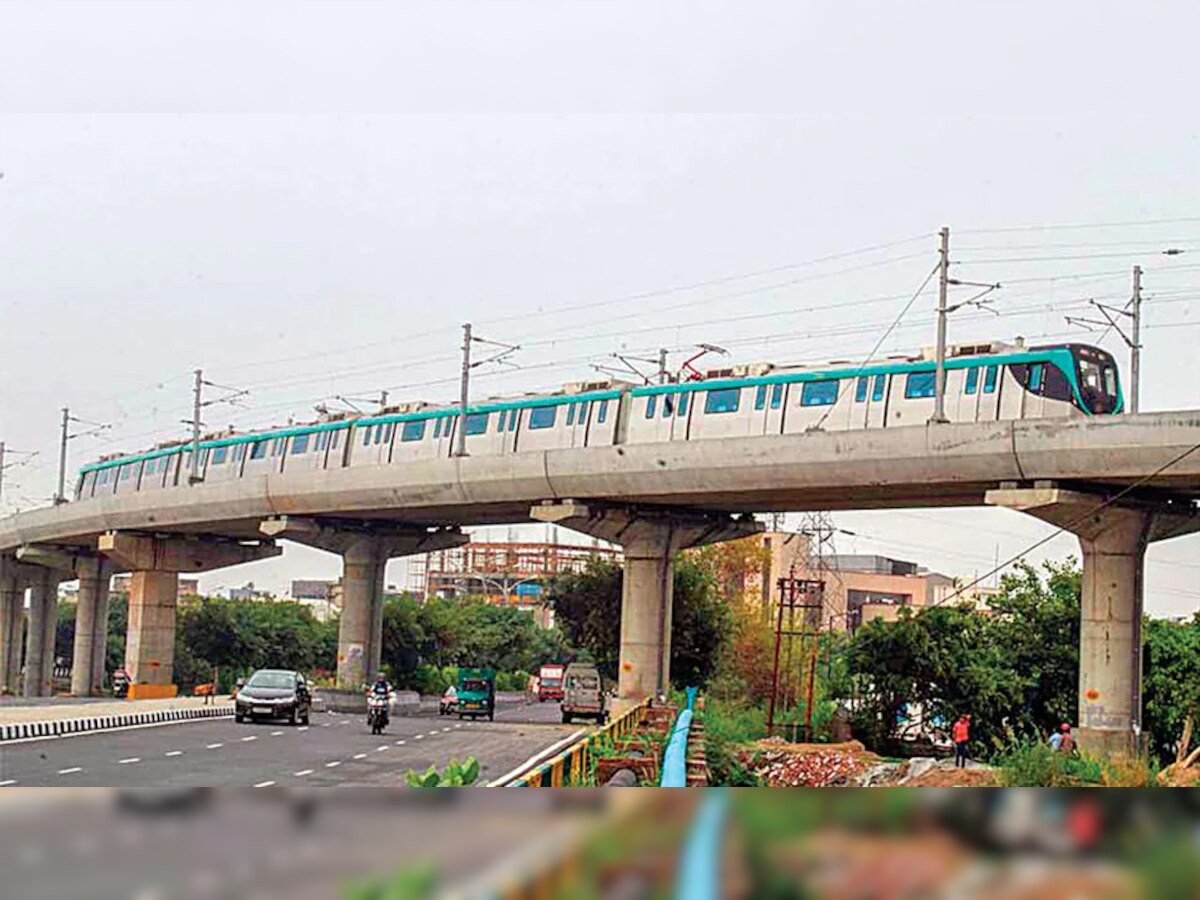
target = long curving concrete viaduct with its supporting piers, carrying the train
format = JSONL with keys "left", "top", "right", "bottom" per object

{"left": 0, "top": 410, "right": 1200, "bottom": 745}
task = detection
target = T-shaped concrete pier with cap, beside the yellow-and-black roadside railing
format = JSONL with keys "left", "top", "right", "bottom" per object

{"left": 529, "top": 500, "right": 763, "bottom": 703}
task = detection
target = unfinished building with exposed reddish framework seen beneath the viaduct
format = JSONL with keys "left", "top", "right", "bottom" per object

{"left": 408, "top": 541, "right": 620, "bottom": 625}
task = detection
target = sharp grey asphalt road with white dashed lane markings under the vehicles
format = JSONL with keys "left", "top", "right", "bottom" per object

{"left": 0, "top": 704, "right": 577, "bottom": 787}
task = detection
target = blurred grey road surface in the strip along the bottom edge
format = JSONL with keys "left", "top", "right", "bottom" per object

{"left": 0, "top": 788, "right": 600, "bottom": 900}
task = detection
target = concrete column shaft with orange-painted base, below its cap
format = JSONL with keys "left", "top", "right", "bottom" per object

{"left": 125, "top": 571, "right": 179, "bottom": 697}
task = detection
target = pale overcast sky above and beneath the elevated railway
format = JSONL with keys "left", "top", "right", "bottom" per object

{"left": 0, "top": 0, "right": 1200, "bottom": 614}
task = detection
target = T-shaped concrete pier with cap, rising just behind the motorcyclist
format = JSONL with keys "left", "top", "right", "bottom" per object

{"left": 259, "top": 516, "right": 470, "bottom": 691}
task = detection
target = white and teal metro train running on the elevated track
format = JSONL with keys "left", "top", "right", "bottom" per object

{"left": 76, "top": 343, "right": 1124, "bottom": 499}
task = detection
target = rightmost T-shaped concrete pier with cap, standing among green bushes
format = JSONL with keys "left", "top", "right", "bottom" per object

{"left": 986, "top": 486, "right": 1200, "bottom": 752}
